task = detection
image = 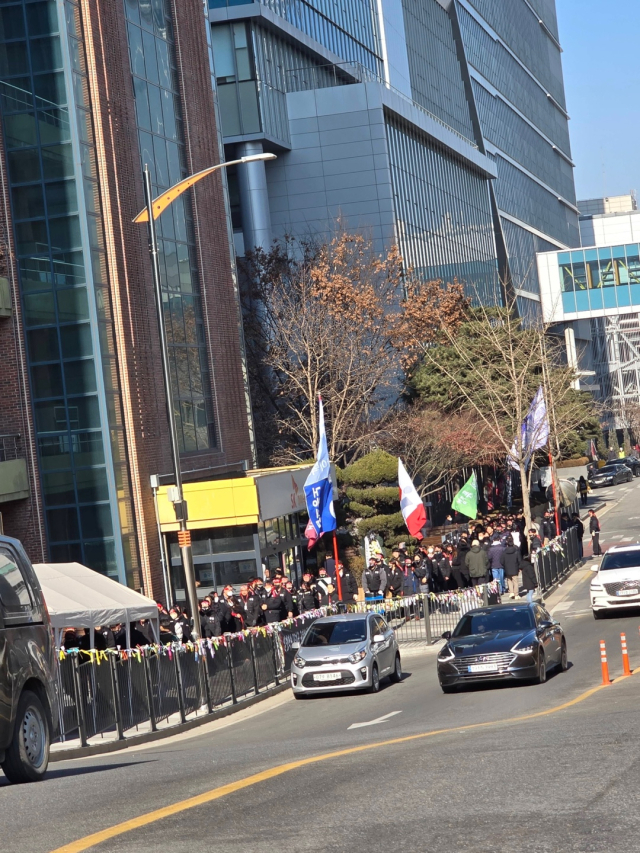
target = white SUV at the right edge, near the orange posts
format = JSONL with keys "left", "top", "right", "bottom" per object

{"left": 590, "top": 545, "right": 640, "bottom": 619}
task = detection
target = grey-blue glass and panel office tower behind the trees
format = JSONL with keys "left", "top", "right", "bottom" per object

{"left": 209, "top": 0, "right": 579, "bottom": 316}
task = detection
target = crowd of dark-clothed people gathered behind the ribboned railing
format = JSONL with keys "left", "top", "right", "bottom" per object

{"left": 63, "top": 502, "right": 599, "bottom": 650}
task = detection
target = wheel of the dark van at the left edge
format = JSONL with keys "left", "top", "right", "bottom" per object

{"left": 2, "top": 690, "right": 51, "bottom": 782}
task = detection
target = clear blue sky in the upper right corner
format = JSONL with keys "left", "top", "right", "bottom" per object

{"left": 556, "top": 0, "right": 640, "bottom": 199}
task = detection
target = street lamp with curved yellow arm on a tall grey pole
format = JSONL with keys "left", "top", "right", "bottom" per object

{"left": 133, "top": 154, "right": 276, "bottom": 639}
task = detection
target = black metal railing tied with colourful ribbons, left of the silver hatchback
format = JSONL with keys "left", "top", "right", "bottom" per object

{"left": 52, "top": 615, "right": 300, "bottom": 746}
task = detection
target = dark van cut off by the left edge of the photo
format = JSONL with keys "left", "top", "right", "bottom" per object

{"left": 0, "top": 536, "right": 58, "bottom": 782}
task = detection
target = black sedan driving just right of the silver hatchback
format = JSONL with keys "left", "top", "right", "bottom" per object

{"left": 437, "top": 602, "right": 568, "bottom": 693}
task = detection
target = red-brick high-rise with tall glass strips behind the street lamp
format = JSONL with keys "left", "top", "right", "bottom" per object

{"left": 0, "top": 0, "right": 252, "bottom": 593}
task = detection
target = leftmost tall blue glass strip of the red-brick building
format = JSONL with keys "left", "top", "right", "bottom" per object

{"left": 0, "top": 0, "right": 137, "bottom": 581}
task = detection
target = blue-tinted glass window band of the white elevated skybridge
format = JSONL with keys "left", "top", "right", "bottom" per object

{"left": 558, "top": 243, "right": 640, "bottom": 314}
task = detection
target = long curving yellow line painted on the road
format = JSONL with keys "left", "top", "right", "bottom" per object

{"left": 51, "top": 669, "right": 640, "bottom": 853}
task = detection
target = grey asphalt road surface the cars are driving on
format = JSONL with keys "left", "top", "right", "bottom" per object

{"left": 0, "top": 480, "right": 640, "bottom": 853}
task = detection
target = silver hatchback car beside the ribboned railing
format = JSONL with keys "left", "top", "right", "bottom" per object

{"left": 291, "top": 613, "right": 402, "bottom": 699}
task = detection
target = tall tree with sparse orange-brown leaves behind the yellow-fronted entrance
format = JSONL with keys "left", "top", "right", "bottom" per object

{"left": 244, "top": 231, "right": 464, "bottom": 462}
